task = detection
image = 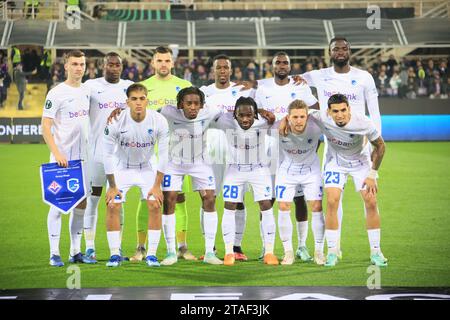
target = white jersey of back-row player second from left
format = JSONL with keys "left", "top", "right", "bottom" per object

{"left": 84, "top": 77, "right": 133, "bottom": 162}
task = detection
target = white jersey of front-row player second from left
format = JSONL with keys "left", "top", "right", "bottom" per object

{"left": 161, "top": 105, "right": 222, "bottom": 164}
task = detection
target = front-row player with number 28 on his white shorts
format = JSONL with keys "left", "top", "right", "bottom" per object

{"left": 214, "top": 97, "right": 278, "bottom": 266}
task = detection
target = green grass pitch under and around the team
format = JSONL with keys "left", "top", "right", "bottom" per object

{"left": 0, "top": 142, "right": 450, "bottom": 289}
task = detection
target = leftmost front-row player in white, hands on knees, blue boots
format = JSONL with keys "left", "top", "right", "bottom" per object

{"left": 103, "top": 84, "right": 169, "bottom": 267}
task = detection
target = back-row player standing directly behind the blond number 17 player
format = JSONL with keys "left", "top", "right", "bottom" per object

{"left": 255, "top": 52, "right": 318, "bottom": 261}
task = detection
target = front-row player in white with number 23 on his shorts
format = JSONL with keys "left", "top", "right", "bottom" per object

{"left": 310, "top": 94, "right": 387, "bottom": 267}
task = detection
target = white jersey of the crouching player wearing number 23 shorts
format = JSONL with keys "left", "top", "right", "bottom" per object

{"left": 309, "top": 110, "right": 380, "bottom": 167}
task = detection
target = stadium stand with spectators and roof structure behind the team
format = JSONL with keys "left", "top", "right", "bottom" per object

{"left": 0, "top": 0, "right": 450, "bottom": 116}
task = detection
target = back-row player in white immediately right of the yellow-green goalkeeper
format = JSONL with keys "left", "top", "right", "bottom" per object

{"left": 200, "top": 54, "right": 254, "bottom": 261}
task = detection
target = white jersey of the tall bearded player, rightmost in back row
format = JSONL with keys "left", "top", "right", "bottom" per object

{"left": 301, "top": 67, "right": 381, "bottom": 129}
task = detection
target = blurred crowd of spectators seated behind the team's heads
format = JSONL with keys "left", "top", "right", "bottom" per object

{"left": 0, "top": 49, "right": 450, "bottom": 109}
